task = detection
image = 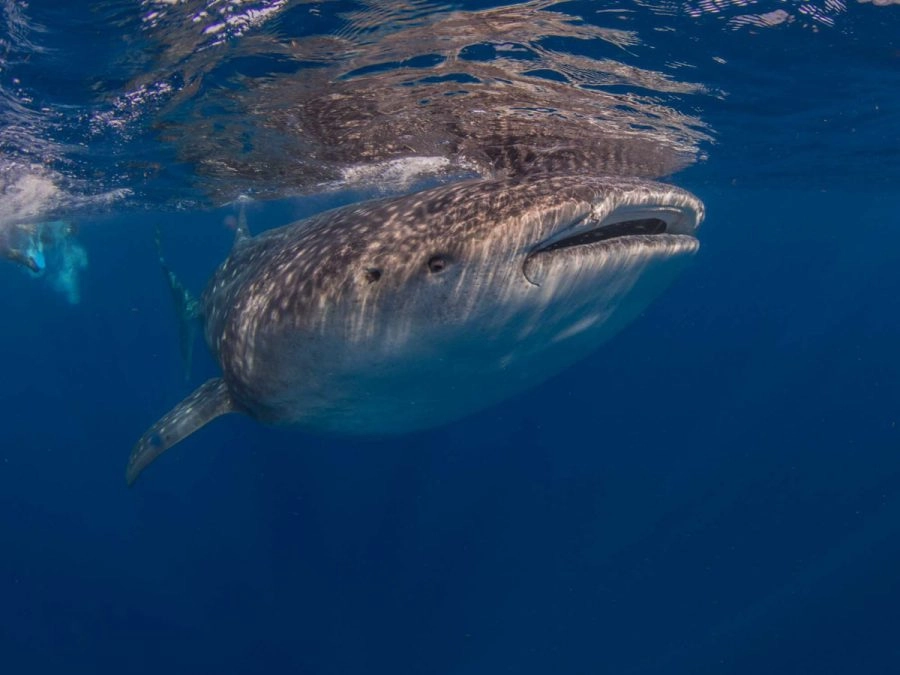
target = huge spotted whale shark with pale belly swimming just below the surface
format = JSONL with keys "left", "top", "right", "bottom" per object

{"left": 126, "top": 174, "right": 704, "bottom": 484}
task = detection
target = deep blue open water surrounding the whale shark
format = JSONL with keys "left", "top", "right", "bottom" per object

{"left": 0, "top": 2, "right": 900, "bottom": 675}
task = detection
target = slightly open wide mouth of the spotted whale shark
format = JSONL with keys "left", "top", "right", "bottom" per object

{"left": 531, "top": 205, "right": 701, "bottom": 255}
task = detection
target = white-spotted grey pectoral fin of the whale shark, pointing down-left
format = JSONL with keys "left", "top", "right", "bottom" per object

{"left": 125, "top": 377, "right": 239, "bottom": 485}
